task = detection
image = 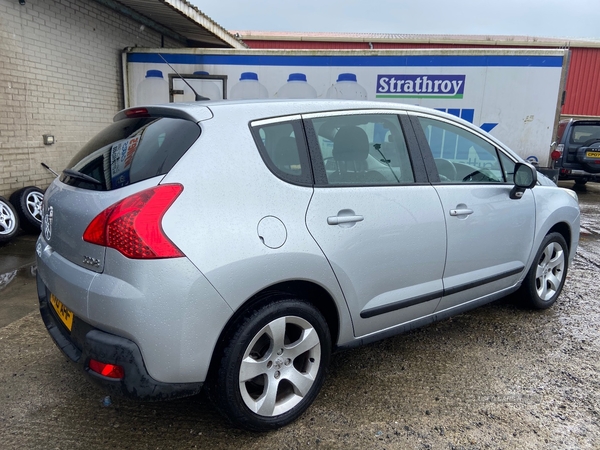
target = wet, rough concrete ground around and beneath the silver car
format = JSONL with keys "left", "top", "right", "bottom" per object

{"left": 0, "top": 183, "right": 600, "bottom": 450}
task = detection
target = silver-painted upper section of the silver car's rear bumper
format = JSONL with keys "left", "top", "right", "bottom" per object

{"left": 36, "top": 232, "right": 232, "bottom": 385}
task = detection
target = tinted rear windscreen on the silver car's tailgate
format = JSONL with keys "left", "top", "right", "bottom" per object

{"left": 61, "top": 118, "right": 200, "bottom": 191}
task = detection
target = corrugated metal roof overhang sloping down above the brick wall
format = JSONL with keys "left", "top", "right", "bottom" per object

{"left": 117, "top": 0, "right": 246, "bottom": 48}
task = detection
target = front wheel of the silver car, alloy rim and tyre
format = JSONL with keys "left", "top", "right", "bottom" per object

{"left": 521, "top": 233, "right": 569, "bottom": 309}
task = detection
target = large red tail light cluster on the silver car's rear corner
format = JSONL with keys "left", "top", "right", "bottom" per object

{"left": 83, "top": 184, "right": 183, "bottom": 259}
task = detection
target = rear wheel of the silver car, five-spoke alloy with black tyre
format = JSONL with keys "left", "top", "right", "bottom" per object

{"left": 209, "top": 299, "right": 331, "bottom": 431}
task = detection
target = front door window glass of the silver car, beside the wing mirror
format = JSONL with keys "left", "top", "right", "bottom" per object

{"left": 418, "top": 117, "right": 506, "bottom": 183}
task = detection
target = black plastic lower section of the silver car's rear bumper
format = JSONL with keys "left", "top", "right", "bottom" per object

{"left": 37, "top": 275, "right": 203, "bottom": 401}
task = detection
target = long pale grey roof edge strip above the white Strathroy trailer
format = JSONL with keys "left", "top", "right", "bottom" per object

{"left": 231, "top": 30, "right": 600, "bottom": 47}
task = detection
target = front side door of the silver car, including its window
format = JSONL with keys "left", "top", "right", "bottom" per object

{"left": 411, "top": 114, "right": 535, "bottom": 311}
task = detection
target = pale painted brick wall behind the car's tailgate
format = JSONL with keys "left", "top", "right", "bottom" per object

{"left": 0, "top": 0, "right": 182, "bottom": 197}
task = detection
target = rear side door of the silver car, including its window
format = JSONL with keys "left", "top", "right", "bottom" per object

{"left": 303, "top": 110, "right": 446, "bottom": 336}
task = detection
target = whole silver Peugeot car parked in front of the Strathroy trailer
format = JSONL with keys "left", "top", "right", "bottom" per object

{"left": 37, "top": 101, "right": 579, "bottom": 430}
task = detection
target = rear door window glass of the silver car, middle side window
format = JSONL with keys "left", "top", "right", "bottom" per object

{"left": 310, "top": 114, "right": 415, "bottom": 186}
